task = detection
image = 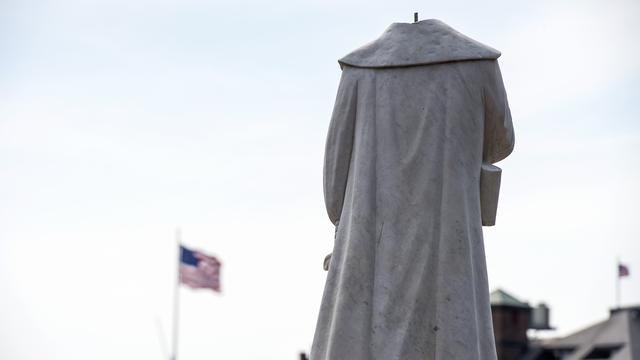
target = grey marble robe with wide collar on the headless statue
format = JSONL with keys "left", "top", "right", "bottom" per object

{"left": 311, "top": 20, "right": 514, "bottom": 360}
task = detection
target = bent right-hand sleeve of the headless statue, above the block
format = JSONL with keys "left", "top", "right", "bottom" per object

{"left": 482, "top": 61, "right": 514, "bottom": 164}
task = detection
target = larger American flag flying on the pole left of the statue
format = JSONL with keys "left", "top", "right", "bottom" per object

{"left": 180, "top": 245, "right": 222, "bottom": 292}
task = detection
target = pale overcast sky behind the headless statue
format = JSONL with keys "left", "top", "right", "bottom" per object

{"left": 0, "top": 0, "right": 640, "bottom": 360}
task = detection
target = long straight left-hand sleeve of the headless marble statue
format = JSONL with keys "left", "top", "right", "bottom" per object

{"left": 323, "top": 67, "right": 357, "bottom": 225}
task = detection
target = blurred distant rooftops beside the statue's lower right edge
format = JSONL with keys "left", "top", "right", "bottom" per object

{"left": 491, "top": 290, "right": 640, "bottom": 360}
